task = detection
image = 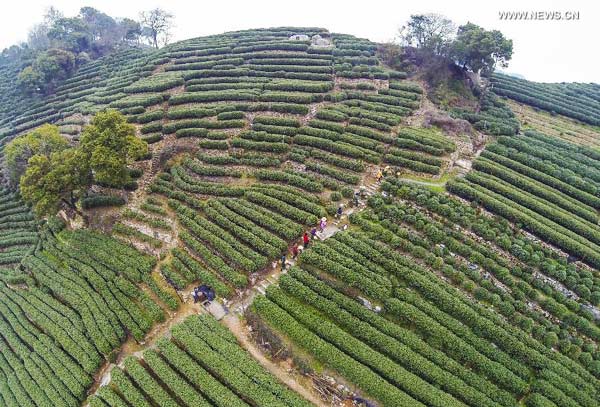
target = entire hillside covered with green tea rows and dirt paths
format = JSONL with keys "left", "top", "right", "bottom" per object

{"left": 0, "top": 21, "right": 600, "bottom": 407}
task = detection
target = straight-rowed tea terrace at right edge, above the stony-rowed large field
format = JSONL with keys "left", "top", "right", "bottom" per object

{"left": 449, "top": 132, "right": 600, "bottom": 267}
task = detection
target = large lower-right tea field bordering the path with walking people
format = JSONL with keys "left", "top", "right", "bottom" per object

{"left": 252, "top": 183, "right": 600, "bottom": 406}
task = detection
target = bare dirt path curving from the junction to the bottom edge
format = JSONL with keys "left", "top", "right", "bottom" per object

{"left": 222, "top": 314, "right": 327, "bottom": 407}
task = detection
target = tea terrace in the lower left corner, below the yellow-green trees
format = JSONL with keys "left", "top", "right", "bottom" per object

{"left": 0, "top": 226, "right": 164, "bottom": 406}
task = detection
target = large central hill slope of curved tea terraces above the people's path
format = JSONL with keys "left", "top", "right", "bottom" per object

{"left": 104, "top": 29, "right": 455, "bottom": 296}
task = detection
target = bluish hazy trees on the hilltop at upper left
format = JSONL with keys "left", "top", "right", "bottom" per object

{"left": 2, "top": 7, "right": 173, "bottom": 94}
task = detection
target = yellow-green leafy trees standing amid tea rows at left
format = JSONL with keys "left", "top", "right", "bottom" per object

{"left": 5, "top": 110, "right": 148, "bottom": 216}
